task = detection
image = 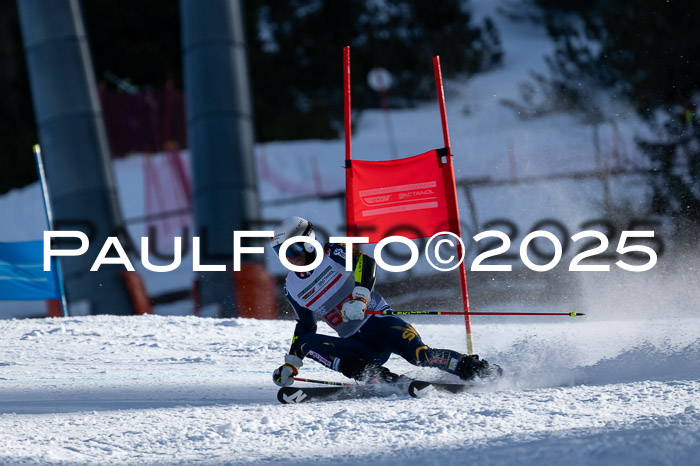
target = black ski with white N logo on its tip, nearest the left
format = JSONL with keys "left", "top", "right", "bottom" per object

{"left": 277, "top": 383, "right": 406, "bottom": 404}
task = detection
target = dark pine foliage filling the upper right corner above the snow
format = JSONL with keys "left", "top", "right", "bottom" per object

{"left": 510, "top": 0, "right": 700, "bottom": 227}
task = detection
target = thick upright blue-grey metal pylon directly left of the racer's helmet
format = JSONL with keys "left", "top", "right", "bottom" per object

{"left": 180, "top": 0, "right": 268, "bottom": 317}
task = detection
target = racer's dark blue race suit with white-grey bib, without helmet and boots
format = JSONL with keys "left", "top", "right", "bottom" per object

{"left": 285, "top": 243, "right": 462, "bottom": 373}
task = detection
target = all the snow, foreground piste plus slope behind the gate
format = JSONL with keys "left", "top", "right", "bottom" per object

{"left": 0, "top": 0, "right": 700, "bottom": 465}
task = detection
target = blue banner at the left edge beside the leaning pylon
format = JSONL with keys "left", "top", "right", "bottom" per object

{"left": 0, "top": 241, "right": 61, "bottom": 301}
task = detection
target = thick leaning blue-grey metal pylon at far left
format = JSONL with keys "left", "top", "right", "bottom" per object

{"left": 17, "top": 0, "right": 134, "bottom": 315}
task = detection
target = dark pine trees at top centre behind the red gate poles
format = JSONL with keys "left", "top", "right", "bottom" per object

{"left": 247, "top": 0, "right": 502, "bottom": 141}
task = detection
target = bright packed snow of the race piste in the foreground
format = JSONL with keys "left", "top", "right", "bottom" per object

{"left": 0, "top": 316, "right": 700, "bottom": 465}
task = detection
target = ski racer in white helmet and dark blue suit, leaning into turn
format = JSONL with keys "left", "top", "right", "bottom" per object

{"left": 271, "top": 217, "right": 501, "bottom": 387}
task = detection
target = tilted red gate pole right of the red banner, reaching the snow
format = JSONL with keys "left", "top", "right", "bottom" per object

{"left": 433, "top": 56, "right": 474, "bottom": 354}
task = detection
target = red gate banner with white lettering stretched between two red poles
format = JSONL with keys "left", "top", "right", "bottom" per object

{"left": 346, "top": 149, "right": 459, "bottom": 243}
